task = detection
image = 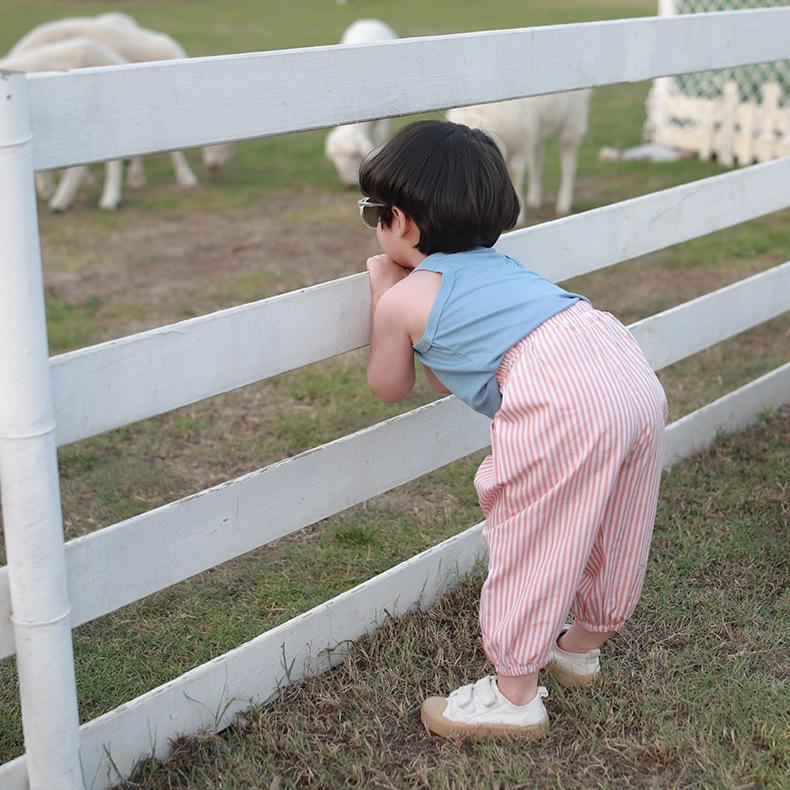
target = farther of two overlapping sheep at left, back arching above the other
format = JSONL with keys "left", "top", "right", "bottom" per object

{"left": 9, "top": 12, "right": 234, "bottom": 189}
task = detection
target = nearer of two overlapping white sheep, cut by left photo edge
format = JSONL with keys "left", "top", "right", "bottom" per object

{"left": 0, "top": 37, "right": 126, "bottom": 211}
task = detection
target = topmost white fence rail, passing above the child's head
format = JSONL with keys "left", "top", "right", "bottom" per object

{"left": 30, "top": 8, "right": 790, "bottom": 169}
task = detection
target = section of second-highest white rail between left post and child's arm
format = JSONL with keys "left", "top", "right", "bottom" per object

{"left": 52, "top": 274, "right": 370, "bottom": 452}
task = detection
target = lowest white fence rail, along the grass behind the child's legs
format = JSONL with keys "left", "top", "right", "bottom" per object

{"left": 0, "top": 363, "right": 790, "bottom": 790}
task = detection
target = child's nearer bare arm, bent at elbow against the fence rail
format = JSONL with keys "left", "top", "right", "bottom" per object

{"left": 367, "top": 255, "right": 415, "bottom": 403}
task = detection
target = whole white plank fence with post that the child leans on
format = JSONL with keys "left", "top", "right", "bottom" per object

{"left": 0, "top": 8, "right": 790, "bottom": 790}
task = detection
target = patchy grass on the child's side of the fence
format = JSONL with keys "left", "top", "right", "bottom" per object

{"left": 119, "top": 411, "right": 790, "bottom": 788}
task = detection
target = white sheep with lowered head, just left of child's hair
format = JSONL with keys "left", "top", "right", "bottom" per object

{"left": 324, "top": 19, "right": 398, "bottom": 186}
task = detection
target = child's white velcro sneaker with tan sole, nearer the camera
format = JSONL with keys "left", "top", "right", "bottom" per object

{"left": 420, "top": 675, "right": 549, "bottom": 740}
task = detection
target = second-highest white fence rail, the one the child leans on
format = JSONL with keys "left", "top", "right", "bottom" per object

{"left": 52, "top": 157, "right": 790, "bottom": 445}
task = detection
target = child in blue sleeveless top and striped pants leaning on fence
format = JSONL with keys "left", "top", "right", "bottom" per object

{"left": 359, "top": 121, "right": 667, "bottom": 738}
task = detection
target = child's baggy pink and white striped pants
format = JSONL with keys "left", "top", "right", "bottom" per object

{"left": 475, "top": 302, "right": 667, "bottom": 675}
